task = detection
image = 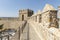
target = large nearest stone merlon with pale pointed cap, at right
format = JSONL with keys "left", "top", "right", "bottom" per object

{"left": 42, "top": 4, "right": 58, "bottom": 27}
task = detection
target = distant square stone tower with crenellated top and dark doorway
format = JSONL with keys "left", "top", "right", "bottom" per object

{"left": 19, "top": 9, "right": 33, "bottom": 21}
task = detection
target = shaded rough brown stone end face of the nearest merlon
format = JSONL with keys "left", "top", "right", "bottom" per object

{"left": 50, "top": 10, "right": 58, "bottom": 27}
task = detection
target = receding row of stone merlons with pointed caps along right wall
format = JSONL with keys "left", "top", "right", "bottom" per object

{"left": 31, "top": 4, "right": 59, "bottom": 28}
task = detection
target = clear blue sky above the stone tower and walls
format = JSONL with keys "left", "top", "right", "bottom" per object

{"left": 0, "top": 0, "right": 60, "bottom": 17}
